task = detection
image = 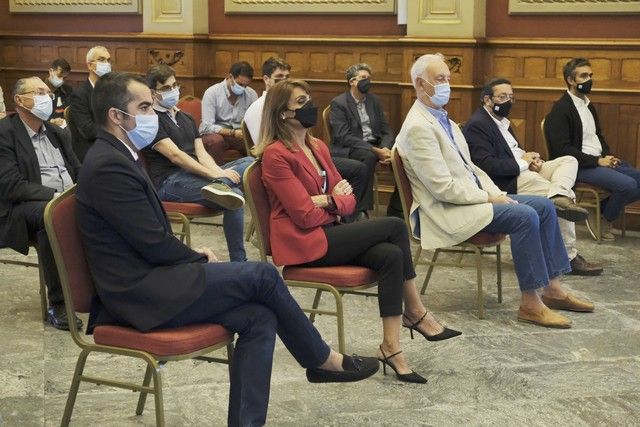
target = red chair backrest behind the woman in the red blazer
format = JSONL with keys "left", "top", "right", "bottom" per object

{"left": 242, "top": 159, "right": 271, "bottom": 261}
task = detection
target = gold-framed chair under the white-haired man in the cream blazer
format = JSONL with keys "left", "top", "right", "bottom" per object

{"left": 391, "top": 147, "right": 502, "bottom": 319}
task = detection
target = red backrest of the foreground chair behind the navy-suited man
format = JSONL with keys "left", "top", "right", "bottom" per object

{"left": 44, "top": 185, "right": 95, "bottom": 318}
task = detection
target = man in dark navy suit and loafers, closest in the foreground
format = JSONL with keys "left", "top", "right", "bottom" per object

{"left": 77, "top": 73, "right": 378, "bottom": 426}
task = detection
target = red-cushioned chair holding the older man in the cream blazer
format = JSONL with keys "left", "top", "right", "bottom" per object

{"left": 391, "top": 147, "right": 506, "bottom": 319}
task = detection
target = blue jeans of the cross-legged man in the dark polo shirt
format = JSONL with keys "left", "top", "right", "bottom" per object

{"left": 158, "top": 157, "right": 254, "bottom": 261}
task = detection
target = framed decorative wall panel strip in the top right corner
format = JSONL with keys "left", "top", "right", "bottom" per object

{"left": 509, "top": 0, "right": 640, "bottom": 15}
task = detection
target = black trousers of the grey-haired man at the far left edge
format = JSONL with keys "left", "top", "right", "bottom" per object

{"left": 13, "top": 201, "right": 64, "bottom": 306}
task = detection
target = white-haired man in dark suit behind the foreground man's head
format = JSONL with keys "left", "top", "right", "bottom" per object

{"left": 68, "top": 46, "right": 111, "bottom": 161}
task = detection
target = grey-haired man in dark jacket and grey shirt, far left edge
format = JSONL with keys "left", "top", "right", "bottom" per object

{"left": 0, "top": 77, "right": 80, "bottom": 330}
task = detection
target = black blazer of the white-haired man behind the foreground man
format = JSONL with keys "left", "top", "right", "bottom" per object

{"left": 69, "top": 79, "right": 98, "bottom": 161}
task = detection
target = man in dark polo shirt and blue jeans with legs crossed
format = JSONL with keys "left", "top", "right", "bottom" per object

{"left": 142, "top": 64, "right": 253, "bottom": 261}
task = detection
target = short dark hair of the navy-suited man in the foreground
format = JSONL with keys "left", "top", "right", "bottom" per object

{"left": 91, "top": 72, "right": 147, "bottom": 127}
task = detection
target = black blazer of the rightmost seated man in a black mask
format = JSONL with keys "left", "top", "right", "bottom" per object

{"left": 544, "top": 92, "right": 611, "bottom": 168}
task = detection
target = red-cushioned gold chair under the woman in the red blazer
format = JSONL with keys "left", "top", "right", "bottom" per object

{"left": 243, "top": 160, "right": 378, "bottom": 353}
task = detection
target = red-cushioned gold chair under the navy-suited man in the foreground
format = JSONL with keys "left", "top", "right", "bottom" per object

{"left": 45, "top": 186, "right": 233, "bottom": 426}
